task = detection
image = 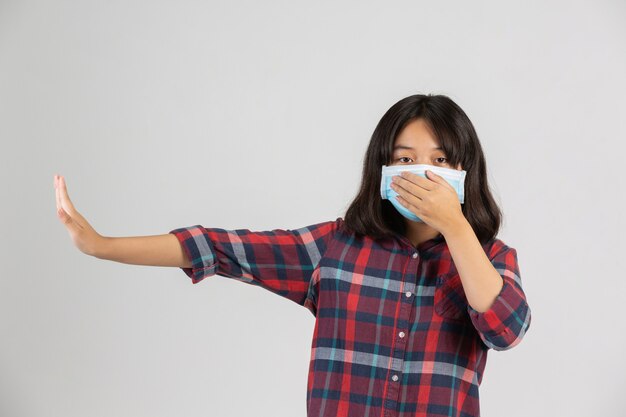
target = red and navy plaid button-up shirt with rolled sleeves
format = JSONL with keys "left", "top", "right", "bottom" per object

{"left": 169, "top": 217, "right": 531, "bottom": 417}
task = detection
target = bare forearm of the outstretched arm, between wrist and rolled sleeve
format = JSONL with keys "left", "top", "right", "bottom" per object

{"left": 93, "top": 233, "right": 191, "bottom": 267}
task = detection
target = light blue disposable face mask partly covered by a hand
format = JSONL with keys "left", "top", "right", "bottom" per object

{"left": 380, "top": 164, "right": 467, "bottom": 222}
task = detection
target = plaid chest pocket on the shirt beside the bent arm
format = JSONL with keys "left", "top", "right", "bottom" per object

{"left": 434, "top": 271, "right": 469, "bottom": 321}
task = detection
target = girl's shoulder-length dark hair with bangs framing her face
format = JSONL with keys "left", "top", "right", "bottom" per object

{"left": 343, "top": 94, "right": 502, "bottom": 244}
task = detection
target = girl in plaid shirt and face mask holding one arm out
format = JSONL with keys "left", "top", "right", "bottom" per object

{"left": 55, "top": 95, "right": 531, "bottom": 417}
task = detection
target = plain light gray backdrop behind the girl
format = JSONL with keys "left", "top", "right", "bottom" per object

{"left": 0, "top": 0, "right": 626, "bottom": 417}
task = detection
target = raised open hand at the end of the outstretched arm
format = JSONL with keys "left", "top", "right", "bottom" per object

{"left": 54, "top": 175, "right": 105, "bottom": 256}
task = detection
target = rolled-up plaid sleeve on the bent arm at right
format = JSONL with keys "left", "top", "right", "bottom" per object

{"left": 467, "top": 244, "right": 531, "bottom": 350}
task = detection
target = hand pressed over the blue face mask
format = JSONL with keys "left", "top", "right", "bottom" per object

{"left": 391, "top": 170, "right": 466, "bottom": 235}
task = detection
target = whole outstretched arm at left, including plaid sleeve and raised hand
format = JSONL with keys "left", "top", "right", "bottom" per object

{"left": 54, "top": 176, "right": 336, "bottom": 308}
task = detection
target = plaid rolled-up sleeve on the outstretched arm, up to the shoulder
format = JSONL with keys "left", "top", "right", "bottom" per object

{"left": 169, "top": 217, "right": 343, "bottom": 306}
